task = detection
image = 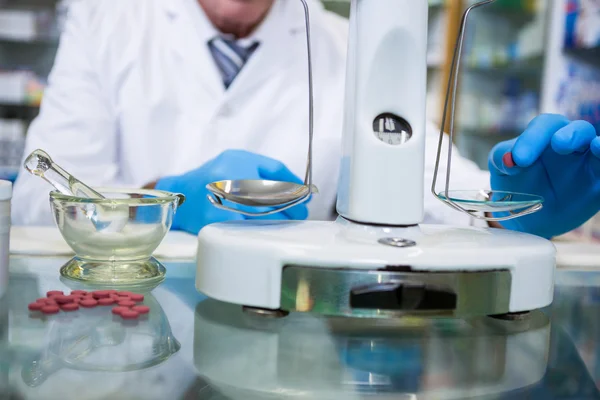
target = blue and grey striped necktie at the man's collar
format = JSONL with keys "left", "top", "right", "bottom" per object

{"left": 208, "top": 36, "right": 259, "bottom": 89}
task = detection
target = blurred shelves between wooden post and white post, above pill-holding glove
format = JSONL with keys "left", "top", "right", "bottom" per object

{"left": 456, "top": 0, "right": 553, "bottom": 169}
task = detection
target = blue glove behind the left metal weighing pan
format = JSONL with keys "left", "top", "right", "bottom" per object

{"left": 155, "top": 150, "right": 308, "bottom": 234}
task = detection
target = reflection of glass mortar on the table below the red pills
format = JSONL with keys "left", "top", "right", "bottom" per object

{"left": 21, "top": 296, "right": 180, "bottom": 387}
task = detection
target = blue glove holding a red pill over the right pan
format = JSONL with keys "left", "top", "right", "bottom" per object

{"left": 489, "top": 114, "right": 600, "bottom": 239}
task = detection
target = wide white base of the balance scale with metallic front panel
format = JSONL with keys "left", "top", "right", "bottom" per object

{"left": 196, "top": 218, "right": 556, "bottom": 317}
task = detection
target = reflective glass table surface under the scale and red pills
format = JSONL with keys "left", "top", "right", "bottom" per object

{"left": 0, "top": 257, "right": 600, "bottom": 400}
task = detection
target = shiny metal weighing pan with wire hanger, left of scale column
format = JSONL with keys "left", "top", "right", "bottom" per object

{"left": 206, "top": 0, "right": 318, "bottom": 216}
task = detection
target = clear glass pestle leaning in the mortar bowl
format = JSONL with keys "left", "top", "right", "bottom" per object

{"left": 24, "top": 150, "right": 129, "bottom": 232}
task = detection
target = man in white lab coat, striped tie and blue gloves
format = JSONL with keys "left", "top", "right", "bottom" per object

{"left": 13, "top": 0, "right": 600, "bottom": 237}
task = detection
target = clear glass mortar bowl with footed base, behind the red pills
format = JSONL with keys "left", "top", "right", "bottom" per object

{"left": 50, "top": 188, "right": 184, "bottom": 289}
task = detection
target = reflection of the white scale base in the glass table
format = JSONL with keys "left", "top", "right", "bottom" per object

{"left": 194, "top": 300, "right": 551, "bottom": 400}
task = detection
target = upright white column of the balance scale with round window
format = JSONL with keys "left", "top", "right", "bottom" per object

{"left": 337, "top": 0, "right": 428, "bottom": 226}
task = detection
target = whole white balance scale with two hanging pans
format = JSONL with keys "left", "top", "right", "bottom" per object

{"left": 196, "top": 0, "right": 556, "bottom": 318}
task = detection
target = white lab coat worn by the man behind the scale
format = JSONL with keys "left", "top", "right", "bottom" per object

{"left": 13, "top": 0, "right": 489, "bottom": 224}
